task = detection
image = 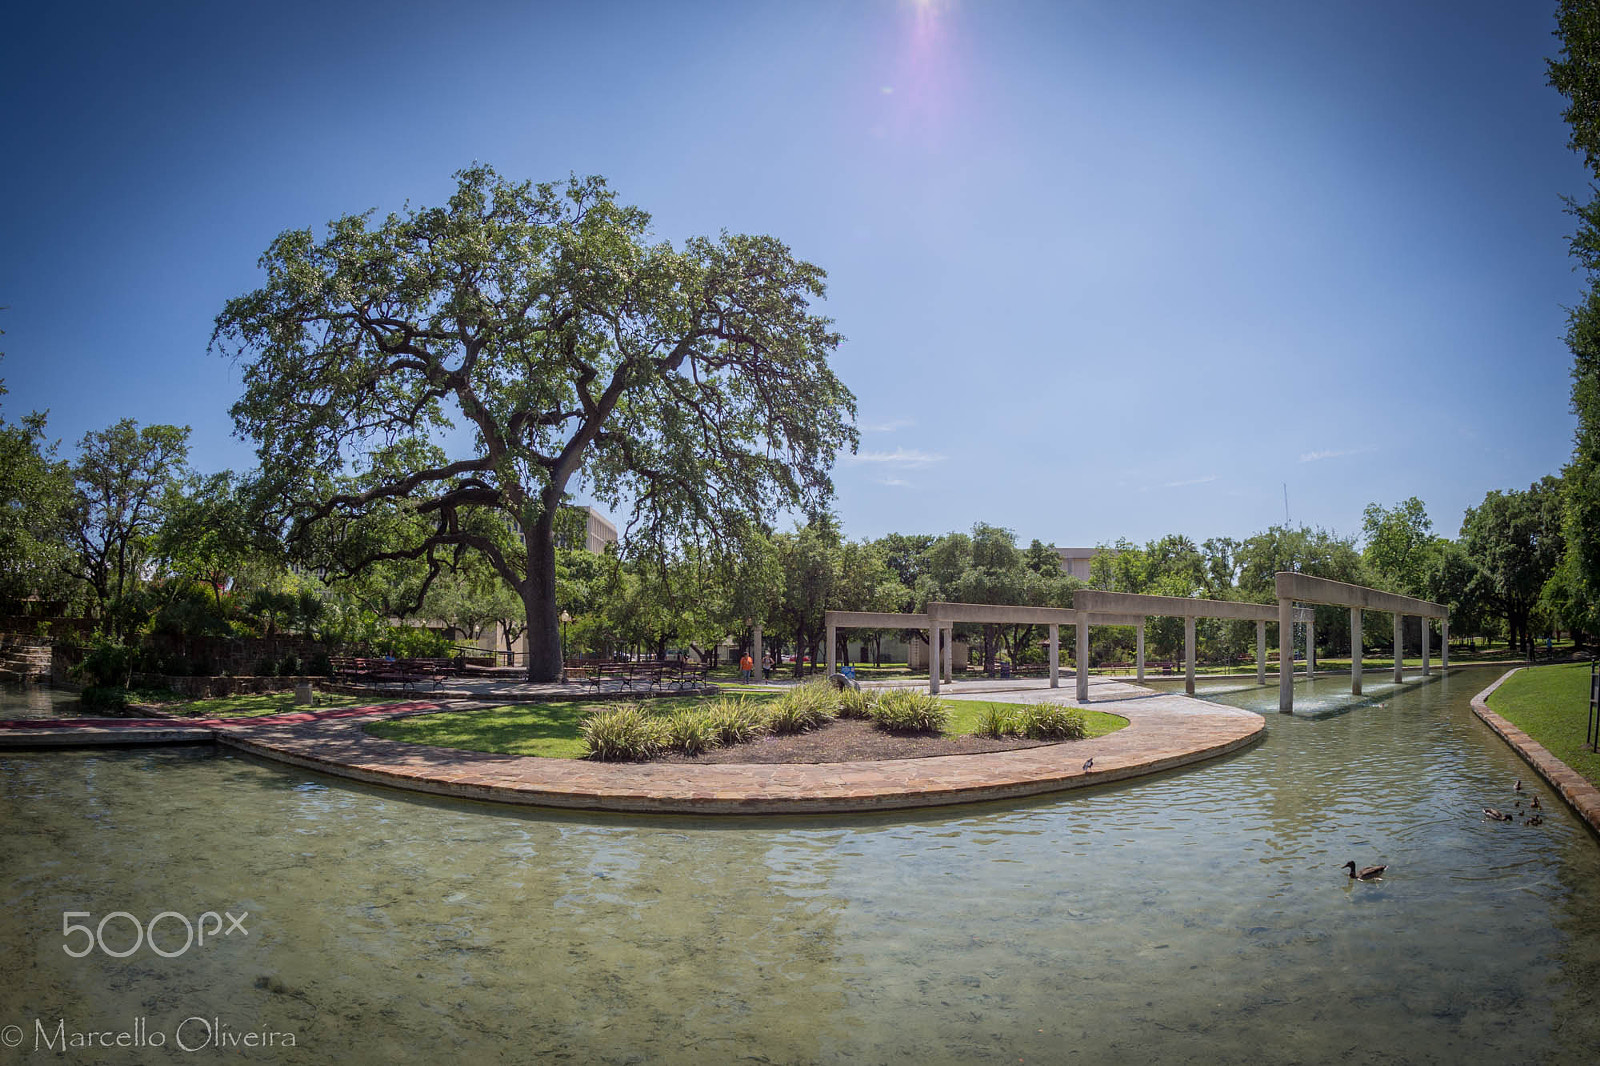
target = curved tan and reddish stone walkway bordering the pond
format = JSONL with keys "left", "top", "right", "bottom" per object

{"left": 0, "top": 679, "right": 1266, "bottom": 815}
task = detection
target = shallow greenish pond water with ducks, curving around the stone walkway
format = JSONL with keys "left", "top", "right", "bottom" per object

{"left": 0, "top": 669, "right": 1600, "bottom": 1063}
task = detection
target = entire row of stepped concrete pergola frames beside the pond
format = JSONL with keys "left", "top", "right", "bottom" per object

{"left": 826, "top": 571, "right": 1450, "bottom": 712}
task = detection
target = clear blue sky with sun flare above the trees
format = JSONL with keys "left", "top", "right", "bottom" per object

{"left": 0, "top": 0, "right": 1587, "bottom": 544}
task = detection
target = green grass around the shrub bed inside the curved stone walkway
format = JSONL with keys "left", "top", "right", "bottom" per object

{"left": 366, "top": 690, "right": 1128, "bottom": 759}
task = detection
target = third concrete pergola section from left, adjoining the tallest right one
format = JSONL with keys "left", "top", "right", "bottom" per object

{"left": 1072, "top": 589, "right": 1317, "bottom": 703}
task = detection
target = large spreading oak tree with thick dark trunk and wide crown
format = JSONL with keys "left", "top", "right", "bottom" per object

{"left": 222, "top": 166, "right": 856, "bottom": 680}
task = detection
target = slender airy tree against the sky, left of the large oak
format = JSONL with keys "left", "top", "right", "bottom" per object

{"left": 70, "top": 418, "right": 189, "bottom": 635}
